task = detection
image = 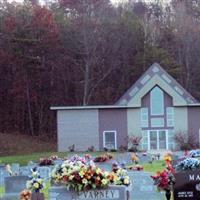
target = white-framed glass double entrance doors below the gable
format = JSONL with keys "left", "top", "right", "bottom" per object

{"left": 148, "top": 130, "right": 168, "bottom": 150}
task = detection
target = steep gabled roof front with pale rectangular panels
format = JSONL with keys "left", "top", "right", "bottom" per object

{"left": 115, "top": 63, "right": 199, "bottom": 107}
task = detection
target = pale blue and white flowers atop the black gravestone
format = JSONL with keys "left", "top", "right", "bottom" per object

{"left": 175, "top": 158, "right": 200, "bottom": 170}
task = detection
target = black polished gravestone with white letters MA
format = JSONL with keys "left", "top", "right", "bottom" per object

{"left": 173, "top": 170, "right": 200, "bottom": 200}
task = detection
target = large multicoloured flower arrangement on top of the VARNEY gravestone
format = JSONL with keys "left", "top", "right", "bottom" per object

{"left": 51, "top": 155, "right": 130, "bottom": 191}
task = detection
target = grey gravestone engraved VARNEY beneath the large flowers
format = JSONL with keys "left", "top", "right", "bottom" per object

{"left": 49, "top": 186, "right": 127, "bottom": 200}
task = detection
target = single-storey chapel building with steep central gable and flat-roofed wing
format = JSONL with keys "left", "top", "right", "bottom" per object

{"left": 51, "top": 63, "right": 200, "bottom": 151}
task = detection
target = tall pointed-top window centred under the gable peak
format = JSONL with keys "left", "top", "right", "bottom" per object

{"left": 150, "top": 86, "right": 164, "bottom": 115}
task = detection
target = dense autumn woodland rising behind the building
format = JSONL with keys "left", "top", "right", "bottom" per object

{"left": 0, "top": 0, "right": 200, "bottom": 137}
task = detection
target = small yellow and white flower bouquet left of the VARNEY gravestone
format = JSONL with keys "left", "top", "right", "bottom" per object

{"left": 26, "top": 168, "right": 44, "bottom": 192}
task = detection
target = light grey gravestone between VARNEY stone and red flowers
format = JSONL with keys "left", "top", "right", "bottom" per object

{"left": 128, "top": 171, "right": 164, "bottom": 200}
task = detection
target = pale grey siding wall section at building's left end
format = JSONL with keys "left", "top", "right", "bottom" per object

{"left": 57, "top": 109, "right": 99, "bottom": 151}
